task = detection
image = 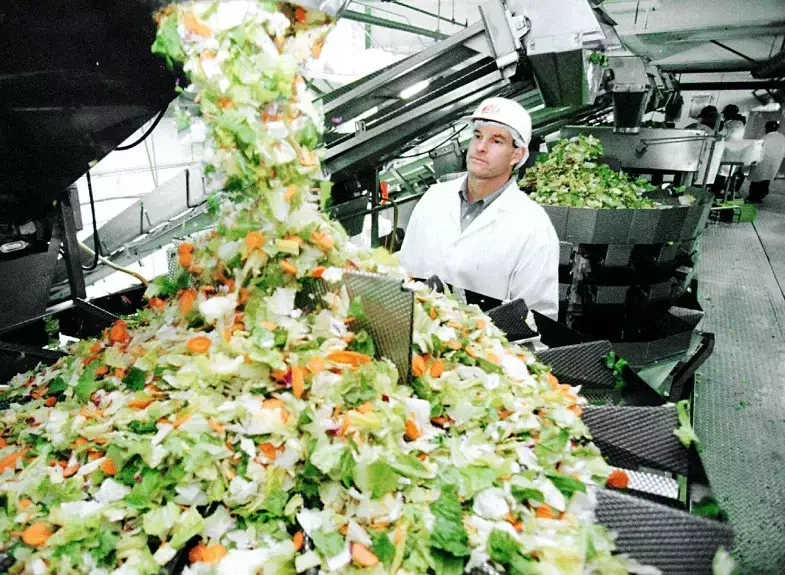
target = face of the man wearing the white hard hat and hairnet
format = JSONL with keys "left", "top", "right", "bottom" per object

{"left": 466, "top": 126, "right": 525, "bottom": 179}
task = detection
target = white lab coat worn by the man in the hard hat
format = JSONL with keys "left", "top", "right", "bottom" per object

{"left": 400, "top": 178, "right": 559, "bottom": 319}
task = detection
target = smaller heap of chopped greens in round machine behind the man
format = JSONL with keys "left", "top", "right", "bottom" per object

{"left": 519, "top": 135, "right": 669, "bottom": 209}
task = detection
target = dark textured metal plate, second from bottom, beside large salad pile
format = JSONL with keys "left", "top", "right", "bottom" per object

{"left": 583, "top": 407, "right": 689, "bottom": 475}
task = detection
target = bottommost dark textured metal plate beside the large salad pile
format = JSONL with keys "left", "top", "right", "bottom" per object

{"left": 596, "top": 489, "right": 733, "bottom": 575}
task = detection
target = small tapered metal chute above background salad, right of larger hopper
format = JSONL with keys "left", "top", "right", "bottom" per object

{"left": 609, "top": 56, "right": 652, "bottom": 134}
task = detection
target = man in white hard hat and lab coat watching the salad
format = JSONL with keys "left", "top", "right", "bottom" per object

{"left": 400, "top": 98, "right": 559, "bottom": 318}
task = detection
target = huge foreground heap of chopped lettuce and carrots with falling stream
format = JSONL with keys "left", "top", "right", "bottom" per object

{"left": 0, "top": 1, "right": 656, "bottom": 575}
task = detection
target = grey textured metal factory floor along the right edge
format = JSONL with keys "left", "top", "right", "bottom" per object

{"left": 695, "top": 181, "right": 785, "bottom": 575}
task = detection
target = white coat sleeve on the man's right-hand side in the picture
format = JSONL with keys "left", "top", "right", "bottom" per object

{"left": 509, "top": 221, "right": 559, "bottom": 319}
